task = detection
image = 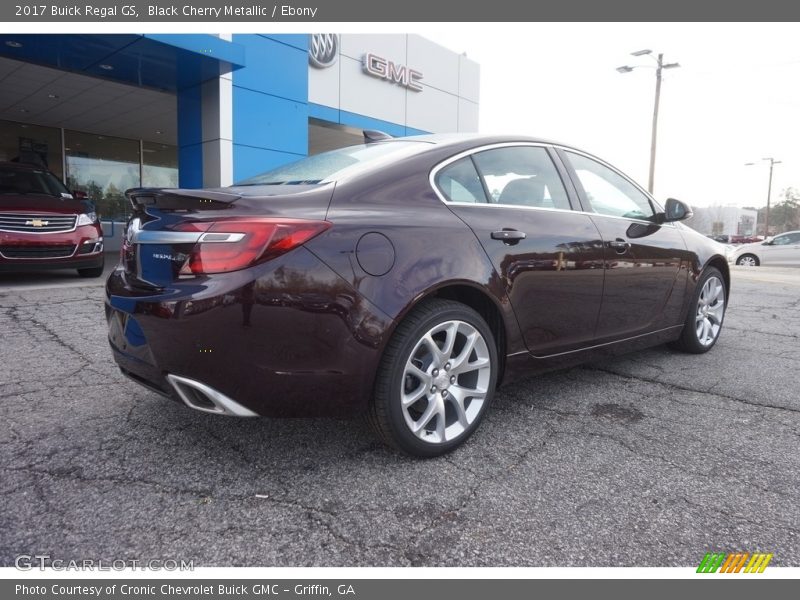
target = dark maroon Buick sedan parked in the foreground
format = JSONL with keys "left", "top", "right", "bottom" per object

{"left": 106, "top": 136, "right": 730, "bottom": 456}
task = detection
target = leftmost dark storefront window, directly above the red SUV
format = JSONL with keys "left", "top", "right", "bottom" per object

{"left": 0, "top": 120, "right": 63, "bottom": 179}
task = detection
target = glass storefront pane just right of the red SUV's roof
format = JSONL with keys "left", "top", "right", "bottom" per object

{"left": 64, "top": 130, "right": 141, "bottom": 221}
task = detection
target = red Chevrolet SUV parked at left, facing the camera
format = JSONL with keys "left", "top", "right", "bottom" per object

{"left": 0, "top": 162, "right": 103, "bottom": 277}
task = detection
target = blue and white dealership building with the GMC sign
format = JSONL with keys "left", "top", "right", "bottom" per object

{"left": 0, "top": 33, "right": 480, "bottom": 234}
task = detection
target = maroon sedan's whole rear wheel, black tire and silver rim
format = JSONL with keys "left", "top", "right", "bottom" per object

{"left": 368, "top": 299, "right": 498, "bottom": 457}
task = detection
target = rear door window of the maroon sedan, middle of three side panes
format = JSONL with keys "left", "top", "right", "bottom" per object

{"left": 473, "top": 146, "right": 572, "bottom": 210}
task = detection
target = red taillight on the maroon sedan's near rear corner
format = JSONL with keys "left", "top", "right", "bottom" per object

{"left": 175, "top": 217, "right": 331, "bottom": 275}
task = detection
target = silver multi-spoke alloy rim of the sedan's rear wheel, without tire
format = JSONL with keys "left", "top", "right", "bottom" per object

{"left": 400, "top": 321, "right": 492, "bottom": 444}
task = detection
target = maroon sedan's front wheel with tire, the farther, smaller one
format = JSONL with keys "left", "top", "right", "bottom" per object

{"left": 671, "top": 267, "right": 728, "bottom": 354}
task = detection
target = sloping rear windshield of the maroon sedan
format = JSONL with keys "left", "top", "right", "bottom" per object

{"left": 235, "top": 141, "right": 423, "bottom": 185}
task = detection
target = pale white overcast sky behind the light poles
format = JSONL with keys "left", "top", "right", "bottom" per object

{"left": 417, "top": 23, "right": 800, "bottom": 207}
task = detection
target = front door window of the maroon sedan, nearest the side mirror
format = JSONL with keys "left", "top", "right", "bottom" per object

{"left": 567, "top": 152, "right": 655, "bottom": 219}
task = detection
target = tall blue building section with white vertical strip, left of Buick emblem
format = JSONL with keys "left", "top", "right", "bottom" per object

{"left": 178, "top": 34, "right": 308, "bottom": 188}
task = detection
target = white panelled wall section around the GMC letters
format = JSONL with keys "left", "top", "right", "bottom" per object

{"left": 308, "top": 34, "right": 480, "bottom": 133}
